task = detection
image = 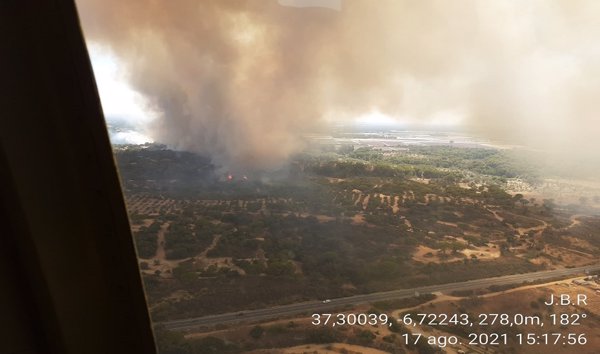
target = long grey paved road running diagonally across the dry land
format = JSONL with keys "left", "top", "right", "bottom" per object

{"left": 162, "top": 265, "right": 600, "bottom": 330}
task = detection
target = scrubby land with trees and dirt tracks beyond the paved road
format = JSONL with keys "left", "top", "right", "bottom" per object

{"left": 116, "top": 142, "right": 600, "bottom": 353}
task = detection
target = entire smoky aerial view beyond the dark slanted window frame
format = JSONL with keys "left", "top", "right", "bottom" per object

{"left": 77, "top": 0, "right": 600, "bottom": 354}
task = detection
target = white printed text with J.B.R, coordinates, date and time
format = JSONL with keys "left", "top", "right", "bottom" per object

{"left": 311, "top": 294, "right": 588, "bottom": 348}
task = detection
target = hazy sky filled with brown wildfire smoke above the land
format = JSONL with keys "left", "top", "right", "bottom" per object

{"left": 78, "top": 0, "right": 600, "bottom": 166}
